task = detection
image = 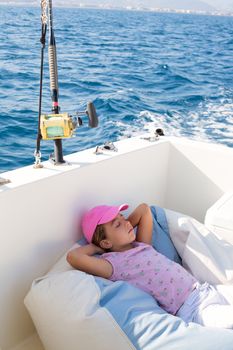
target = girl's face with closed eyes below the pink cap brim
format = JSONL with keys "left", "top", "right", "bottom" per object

{"left": 102, "top": 213, "right": 136, "bottom": 251}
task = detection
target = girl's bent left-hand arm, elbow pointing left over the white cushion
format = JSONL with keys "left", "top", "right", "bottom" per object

{"left": 66, "top": 244, "right": 112, "bottom": 278}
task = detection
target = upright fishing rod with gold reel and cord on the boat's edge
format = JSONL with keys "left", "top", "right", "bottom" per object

{"left": 34, "top": 0, "right": 98, "bottom": 168}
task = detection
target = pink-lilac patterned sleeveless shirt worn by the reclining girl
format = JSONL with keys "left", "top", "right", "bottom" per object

{"left": 102, "top": 242, "right": 197, "bottom": 315}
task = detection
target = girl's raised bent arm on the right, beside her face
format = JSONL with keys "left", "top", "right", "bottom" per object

{"left": 128, "top": 203, "right": 153, "bottom": 244}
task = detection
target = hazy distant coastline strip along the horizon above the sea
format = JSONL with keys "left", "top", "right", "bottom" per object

{"left": 0, "top": 0, "right": 233, "bottom": 16}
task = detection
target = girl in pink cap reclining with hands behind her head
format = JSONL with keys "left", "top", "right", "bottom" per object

{"left": 67, "top": 203, "right": 233, "bottom": 329}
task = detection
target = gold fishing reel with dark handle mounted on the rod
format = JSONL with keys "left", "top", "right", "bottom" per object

{"left": 40, "top": 102, "right": 98, "bottom": 140}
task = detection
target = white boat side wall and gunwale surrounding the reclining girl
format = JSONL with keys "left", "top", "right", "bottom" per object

{"left": 0, "top": 135, "right": 233, "bottom": 350}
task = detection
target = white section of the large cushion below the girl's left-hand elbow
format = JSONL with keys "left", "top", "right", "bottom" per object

{"left": 24, "top": 244, "right": 135, "bottom": 350}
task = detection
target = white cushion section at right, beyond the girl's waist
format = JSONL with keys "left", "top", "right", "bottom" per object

{"left": 165, "top": 209, "right": 233, "bottom": 284}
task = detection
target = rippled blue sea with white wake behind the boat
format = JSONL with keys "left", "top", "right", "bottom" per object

{"left": 0, "top": 6, "right": 233, "bottom": 172}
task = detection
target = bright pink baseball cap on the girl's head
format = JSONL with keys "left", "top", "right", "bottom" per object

{"left": 82, "top": 204, "right": 129, "bottom": 243}
